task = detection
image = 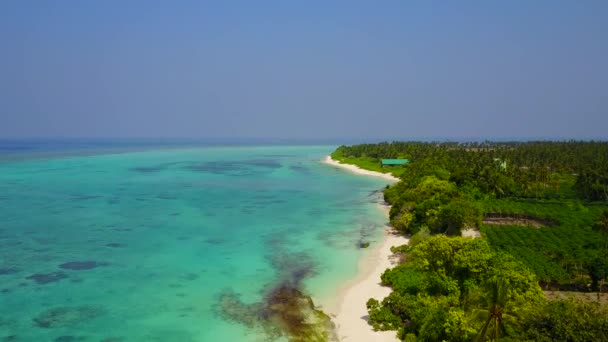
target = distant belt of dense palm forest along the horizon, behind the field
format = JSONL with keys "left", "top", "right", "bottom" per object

{"left": 332, "top": 141, "right": 608, "bottom": 202}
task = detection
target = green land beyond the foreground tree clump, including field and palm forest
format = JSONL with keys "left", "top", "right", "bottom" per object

{"left": 334, "top": 141, "right": 608, "bottom": 291}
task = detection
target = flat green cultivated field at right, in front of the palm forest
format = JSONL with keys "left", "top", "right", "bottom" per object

{"left": 479, "top": 199, "right": 606, "bottom": 285}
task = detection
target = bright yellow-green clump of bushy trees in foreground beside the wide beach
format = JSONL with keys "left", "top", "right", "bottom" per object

{"left": 367, "top": 235, "right": 544, "bottom": 341}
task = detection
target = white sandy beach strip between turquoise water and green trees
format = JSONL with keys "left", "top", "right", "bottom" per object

{"left": 323, "top": 156, "right": 409, "bottom": 342}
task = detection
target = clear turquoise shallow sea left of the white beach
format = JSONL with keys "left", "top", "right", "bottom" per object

{"left": 0, "top": 146, "right": 386, "bottom": 342}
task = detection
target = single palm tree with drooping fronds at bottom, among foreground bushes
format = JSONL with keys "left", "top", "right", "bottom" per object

{"left": 472, "top": 278, "right": 516, "bottom": 341}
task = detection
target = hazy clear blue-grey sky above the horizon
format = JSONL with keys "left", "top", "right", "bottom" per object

{"left": 0, "top": 0, "right": 608, "bottom": 141}
